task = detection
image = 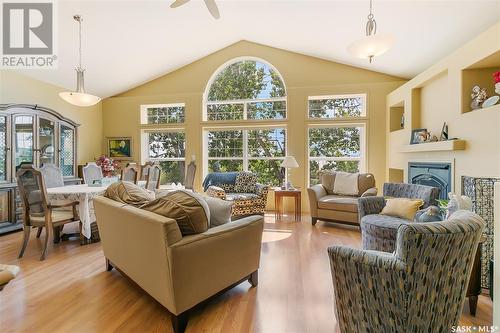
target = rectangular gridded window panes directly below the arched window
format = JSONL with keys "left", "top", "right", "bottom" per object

{"left": 205, "top": 128, "right": 286, "bottom": 185}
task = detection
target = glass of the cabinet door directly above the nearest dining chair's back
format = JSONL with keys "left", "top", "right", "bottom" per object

{"left": 13, "top": 115, "right": 33, "bottom": 172}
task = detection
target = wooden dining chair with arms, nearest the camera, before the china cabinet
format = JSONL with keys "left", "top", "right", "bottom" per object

{"left": 16, "top": 165, "right": 79, "bottom": 260}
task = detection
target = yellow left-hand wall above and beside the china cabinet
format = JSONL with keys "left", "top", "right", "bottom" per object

{"left": 0, "top": 70, "right": 103, "bottom": 164}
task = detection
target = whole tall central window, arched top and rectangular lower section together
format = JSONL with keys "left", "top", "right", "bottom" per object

{"left": 203, "top": 58, "right": 287, "bottom": 185}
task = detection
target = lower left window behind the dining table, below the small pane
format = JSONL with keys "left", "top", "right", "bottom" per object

{"left": 146, "top": 131, "right": 186, "bottom": 184}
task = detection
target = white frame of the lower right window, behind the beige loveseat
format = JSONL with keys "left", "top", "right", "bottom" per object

{"left": 306, "top": 122, "right": 367, "bottom": 186}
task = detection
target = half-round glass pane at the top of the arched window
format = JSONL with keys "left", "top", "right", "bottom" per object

{"left": 208, "top": 60, "right": 285, "bottom": 101}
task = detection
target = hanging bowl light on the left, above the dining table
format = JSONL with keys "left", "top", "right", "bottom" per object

{"left": 59, "top": 15, "right": 101, "bottom": 106}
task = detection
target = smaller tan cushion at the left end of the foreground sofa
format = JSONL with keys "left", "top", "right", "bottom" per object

{"left": 104, "top": 182, "right": 155, "bottom": 207}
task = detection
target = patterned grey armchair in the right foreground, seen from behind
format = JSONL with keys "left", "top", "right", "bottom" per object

{"left": 328, "top": 211, "right": 484, "bottom": 333}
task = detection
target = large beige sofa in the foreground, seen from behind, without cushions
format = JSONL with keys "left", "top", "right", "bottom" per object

{"left": 94, "top": 197, "right": 264, "bottom": 333}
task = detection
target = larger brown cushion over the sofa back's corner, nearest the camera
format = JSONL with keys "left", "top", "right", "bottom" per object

{"left": 141, "top": 190, "right": 210, "bottom": 236}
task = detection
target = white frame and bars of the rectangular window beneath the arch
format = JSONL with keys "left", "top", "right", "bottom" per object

{"left": 203, "top": 124, "right": 288, "bottom": 182}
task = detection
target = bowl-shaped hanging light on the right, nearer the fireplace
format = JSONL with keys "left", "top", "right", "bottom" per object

{"left": 347, "top": 0, "right": 395, "bottom": 63}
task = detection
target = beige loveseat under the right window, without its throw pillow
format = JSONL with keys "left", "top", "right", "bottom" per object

{"left": 307, "top": 172, "right": 377, "bottom": 225}
